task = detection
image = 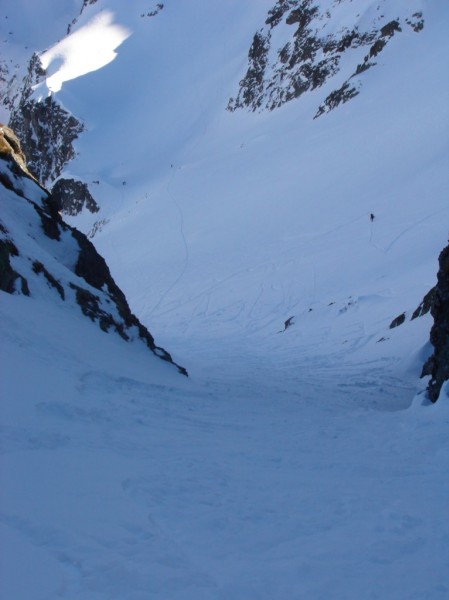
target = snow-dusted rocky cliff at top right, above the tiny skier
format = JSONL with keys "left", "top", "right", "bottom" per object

{"left": 228, "top": 0, "right": 424, "bottom": 117}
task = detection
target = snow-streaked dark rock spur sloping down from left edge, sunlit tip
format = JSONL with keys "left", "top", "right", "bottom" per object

{"left": 0, "top": 126, "right": 187, "bottom": 375}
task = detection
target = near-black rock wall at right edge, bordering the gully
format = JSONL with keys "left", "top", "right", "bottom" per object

{"left": 421, "top": 245, "right": 449, "bottom": 402}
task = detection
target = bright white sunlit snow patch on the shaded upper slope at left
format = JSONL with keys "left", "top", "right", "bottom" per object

{"left": 40, "top": 11, "right": 131, "bottom": 92}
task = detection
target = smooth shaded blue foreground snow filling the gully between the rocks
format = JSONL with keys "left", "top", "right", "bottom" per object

{"left": 0, "top": 296, "right": 449, "bottom": 600}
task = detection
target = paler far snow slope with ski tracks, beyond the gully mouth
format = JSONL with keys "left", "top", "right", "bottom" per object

{"left": 41, "top": 2, "right": 448, "bottom": 406}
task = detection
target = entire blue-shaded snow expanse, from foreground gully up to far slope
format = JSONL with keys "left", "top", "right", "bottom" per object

{"left": 0, "top": 0, "right": 449, "bottom": 600}
